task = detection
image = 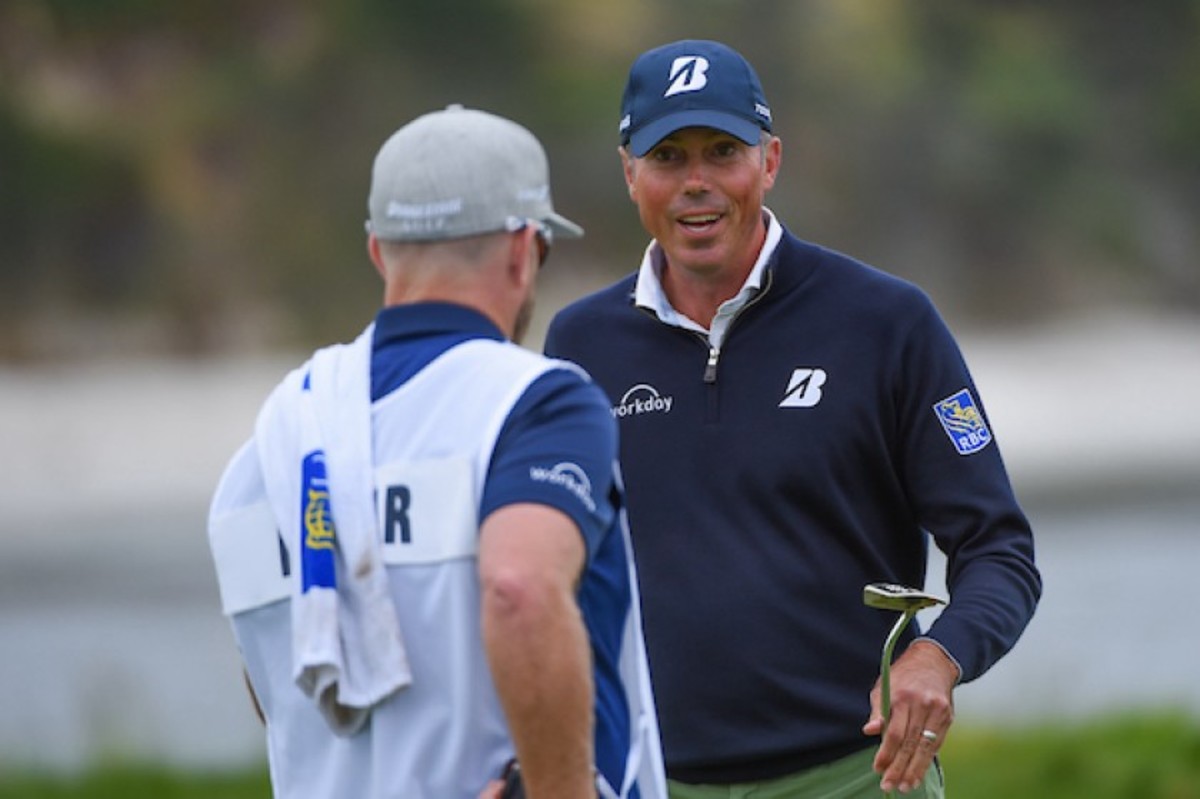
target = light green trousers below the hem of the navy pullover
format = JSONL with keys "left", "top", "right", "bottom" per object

{"left": 667, "top": 746, "right": 946, "bottom": 799}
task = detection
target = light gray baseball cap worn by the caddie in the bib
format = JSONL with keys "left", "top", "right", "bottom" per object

{"left": 367, "top": 104, "right": 583, "bottom": 241}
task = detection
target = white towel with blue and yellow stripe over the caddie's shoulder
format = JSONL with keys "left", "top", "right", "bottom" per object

{"left": 256, "top": 325, "right": 413, "bottom": 735}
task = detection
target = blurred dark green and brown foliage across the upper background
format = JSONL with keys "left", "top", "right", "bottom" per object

{"left": 0, "top": 0, "right": 1200, "bottom": 360}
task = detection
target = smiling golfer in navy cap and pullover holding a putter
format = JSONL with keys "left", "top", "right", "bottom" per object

{"left": 546, "top": 41, "right": 1042, "bottom": 799}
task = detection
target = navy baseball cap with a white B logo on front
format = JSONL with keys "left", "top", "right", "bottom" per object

{"left": 619, "top": 40, "right": 770, "bottom": 158}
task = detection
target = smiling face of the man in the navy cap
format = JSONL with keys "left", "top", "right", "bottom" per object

{"left": 623, "top": 127, "right": 780, "bottom": 279}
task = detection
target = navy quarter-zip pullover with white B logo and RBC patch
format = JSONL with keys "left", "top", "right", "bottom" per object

{"left": 546, "top": 220, "right": 1042, "bottom": 783}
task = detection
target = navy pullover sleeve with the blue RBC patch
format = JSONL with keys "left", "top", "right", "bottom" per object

{"left": 898, "top": 298, "right": 1042, "bottom": 681}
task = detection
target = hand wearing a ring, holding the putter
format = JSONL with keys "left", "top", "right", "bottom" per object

{"left": 863, "top": 641, "right": 959, "bottom": 793}
